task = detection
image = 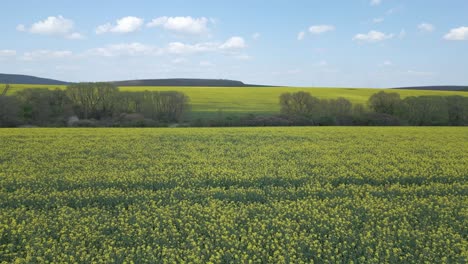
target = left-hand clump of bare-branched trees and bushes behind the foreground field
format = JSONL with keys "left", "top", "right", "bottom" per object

{"left": 0, "top": 83, "right": 190, "bottom": 127}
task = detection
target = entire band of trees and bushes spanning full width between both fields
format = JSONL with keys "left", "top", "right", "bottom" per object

{"left": 0, "top": 83, "right": 468, "bottom": 127}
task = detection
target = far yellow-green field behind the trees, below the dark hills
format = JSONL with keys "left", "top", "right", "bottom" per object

{"left": 0, "top": 85, "right": 468, "bottom": 118}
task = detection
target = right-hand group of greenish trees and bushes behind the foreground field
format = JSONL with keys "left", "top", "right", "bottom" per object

{"left": 279, "top": 91, "right": 468, "bottom": 126}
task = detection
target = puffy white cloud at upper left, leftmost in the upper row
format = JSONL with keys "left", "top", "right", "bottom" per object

{"left": 16, "top": 16, "right": 83, "bottom": 39}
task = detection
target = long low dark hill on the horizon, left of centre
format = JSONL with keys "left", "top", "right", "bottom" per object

{"left": 112, "top": 79, "right": 270, "bottom": 87}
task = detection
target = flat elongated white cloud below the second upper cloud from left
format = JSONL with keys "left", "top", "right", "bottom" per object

{"left": 85, "top": 42, "right": 163, "bottom": 57}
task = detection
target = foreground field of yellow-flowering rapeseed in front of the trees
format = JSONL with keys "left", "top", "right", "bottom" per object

{"left": 0, "top": 127, "right": 468, "bottom": 263}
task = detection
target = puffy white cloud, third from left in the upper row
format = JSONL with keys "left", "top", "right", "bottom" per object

{"left": 146, "top": 16, "right": 210, "bottom": 34}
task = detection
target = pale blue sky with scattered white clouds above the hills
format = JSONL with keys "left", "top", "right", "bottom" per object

{"left": 0, "top": 0, "right": 468, "bottom": 87}
